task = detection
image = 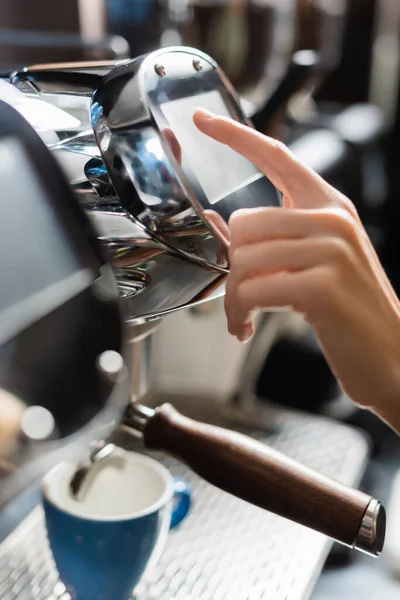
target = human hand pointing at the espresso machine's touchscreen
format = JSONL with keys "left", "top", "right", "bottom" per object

{"left": 194, "top": 110, "right": 400, "bottom": 431}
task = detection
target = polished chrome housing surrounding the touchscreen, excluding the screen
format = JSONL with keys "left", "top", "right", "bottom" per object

{"left": 7, "top": 47, "right": 279, "bottom": 323}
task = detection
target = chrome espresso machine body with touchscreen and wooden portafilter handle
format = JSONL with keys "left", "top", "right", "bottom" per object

{"left": 0, "top": 47, "right": 385, "bottom": 576}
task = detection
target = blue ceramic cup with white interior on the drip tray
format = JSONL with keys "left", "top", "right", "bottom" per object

{"left": 43, "top": 449, "right": 191, "bottom": 600}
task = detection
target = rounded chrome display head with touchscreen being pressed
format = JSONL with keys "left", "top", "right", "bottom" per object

{"left": 91, "top": 47, "right": 279, "bottom": 251}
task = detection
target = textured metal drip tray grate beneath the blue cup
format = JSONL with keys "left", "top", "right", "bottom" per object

{"left": 0, "top": 398, "right": 368, "bottom": 600}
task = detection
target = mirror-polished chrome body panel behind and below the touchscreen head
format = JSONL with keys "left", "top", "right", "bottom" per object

{"left": 7, "top": 61, "right": 228, "bottom": 323}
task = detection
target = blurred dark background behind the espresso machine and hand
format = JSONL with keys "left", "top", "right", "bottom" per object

{"left": 0, "top": 0, "right": 400, "bottom": 600}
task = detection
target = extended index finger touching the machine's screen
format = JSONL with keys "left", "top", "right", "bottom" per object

{"left": 193, "top": 109, "right": 333, "bottom": 208}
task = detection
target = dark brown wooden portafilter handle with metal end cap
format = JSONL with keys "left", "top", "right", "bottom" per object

{"left": 125, "top": 404, "right": 386, "bottom": 556}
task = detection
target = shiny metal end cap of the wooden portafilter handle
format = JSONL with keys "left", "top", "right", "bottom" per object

{"left": 354, "top": 500, "right": 386, "bottom": 556}
